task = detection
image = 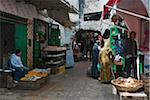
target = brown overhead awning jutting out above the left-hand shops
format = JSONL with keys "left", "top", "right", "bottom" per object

{"left": 20, "top": 0, "right": 78, "bottom": 26}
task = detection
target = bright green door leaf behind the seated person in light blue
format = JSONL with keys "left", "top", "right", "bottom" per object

{"left": 15, "top": 23, "right": 27, "bottom": 64}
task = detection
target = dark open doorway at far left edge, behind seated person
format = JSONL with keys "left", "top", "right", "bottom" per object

{"left": 0, "top": 22, "right": 15, "bottom": 68}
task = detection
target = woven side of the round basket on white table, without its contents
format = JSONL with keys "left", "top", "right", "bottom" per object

{"left": 111, "top": 79, "right": 143, "bottom": 92}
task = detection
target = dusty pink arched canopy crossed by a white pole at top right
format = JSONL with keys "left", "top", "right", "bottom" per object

{"left": 117, "top": 0, "right": 149, "bottom": 33}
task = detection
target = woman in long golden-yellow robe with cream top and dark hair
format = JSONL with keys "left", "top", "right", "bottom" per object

{"left": 98, "top": 29, "right": 113, "bottom": 83}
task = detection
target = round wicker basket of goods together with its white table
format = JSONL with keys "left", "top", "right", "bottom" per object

{"left": 111, "top": 77, "right": 148, "bottom": 100}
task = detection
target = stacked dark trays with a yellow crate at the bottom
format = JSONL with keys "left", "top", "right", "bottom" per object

{"left": 44, "top": 46, "right": 66, "bottom": 74}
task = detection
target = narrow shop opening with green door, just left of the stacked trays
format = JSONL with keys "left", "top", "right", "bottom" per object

{"left": 33, "top": 19, "right": 49, "bottom": 67}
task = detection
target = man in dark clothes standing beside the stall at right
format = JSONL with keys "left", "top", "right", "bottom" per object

{"left": 123, "top": 31, "right": 137, "bottom": 79}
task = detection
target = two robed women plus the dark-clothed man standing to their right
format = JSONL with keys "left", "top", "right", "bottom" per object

{"left": 91, "top": 29, "right": 137, "bottom": 82}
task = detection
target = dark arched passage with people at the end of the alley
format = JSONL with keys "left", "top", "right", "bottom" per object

{"left": 72, "top": 29, "right": 101, "bottom": 61}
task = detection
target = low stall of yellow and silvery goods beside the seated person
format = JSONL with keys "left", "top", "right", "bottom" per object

{"left": 18, "top": 68, "right": 51, "bottom": 90}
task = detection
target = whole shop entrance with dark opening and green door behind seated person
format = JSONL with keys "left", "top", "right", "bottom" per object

{"left": 0, "top": 12, "right": 27, "bottom": 69}
